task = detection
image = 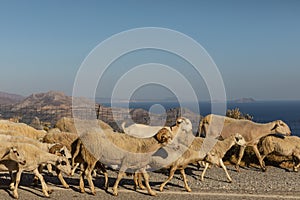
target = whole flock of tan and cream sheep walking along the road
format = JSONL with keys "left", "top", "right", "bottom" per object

{"left": 0, "top": 114, "right": 300, "bottom": 198}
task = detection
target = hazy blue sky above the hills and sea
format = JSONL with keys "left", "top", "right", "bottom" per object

{"left": 0, "top": 0, "right": 300, "bottom": 100}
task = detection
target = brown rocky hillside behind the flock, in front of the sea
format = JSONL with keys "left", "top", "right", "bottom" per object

{"left": 0, "top": 91, "right": 200, "bottom": 131}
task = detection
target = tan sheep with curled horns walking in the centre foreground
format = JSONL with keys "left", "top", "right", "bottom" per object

{"left": 72, "top": 124, "right": 180, "bottom": 196}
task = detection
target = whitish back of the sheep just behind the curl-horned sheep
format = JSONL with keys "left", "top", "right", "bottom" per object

{"left": 121, "top": 122, "right": 163, "bottom": 138}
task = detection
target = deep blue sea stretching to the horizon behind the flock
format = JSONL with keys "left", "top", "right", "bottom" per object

{"left": 104, "top": 101, "right": 300, "bottom": 136}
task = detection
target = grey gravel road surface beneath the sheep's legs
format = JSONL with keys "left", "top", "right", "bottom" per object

{"left": 0, "top": 166, "right": 300, "bottom": 200}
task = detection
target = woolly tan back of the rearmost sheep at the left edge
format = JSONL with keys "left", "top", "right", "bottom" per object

{"left": 0, "top": 120, "right": 46, "bottom": 140}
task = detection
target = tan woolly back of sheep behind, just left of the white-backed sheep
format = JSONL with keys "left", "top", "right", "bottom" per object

{"left": 55, "top": 117, "right": 113, "bottom": 133}
